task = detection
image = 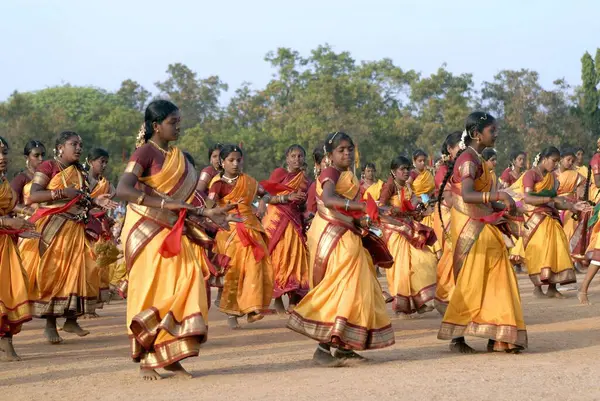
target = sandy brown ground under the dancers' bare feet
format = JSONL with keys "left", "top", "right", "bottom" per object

{"left": 0, "top": 275, "right": 600, "bottom": 401}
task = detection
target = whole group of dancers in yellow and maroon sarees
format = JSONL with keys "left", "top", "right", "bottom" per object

{"left": 0, "top": 100, "right": 600, "bottom": 380}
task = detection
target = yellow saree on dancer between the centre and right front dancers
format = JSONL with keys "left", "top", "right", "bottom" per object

{"left": 382, "top": 183, "right": 437, "bottom": 314}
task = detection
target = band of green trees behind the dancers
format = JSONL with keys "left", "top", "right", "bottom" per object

{"left": 0, "top": 45, "right": 600, "bottom": 180}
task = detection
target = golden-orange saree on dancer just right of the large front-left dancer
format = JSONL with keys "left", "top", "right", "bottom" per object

{"left": 211, "top": 174, "right": 273, "bottom": 316}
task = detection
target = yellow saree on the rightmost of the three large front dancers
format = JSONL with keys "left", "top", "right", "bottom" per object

{"left": 438, "top": 149, "right": 527, "bottom": 350}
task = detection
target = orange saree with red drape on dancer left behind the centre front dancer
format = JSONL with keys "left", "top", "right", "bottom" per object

{"left": 262, "top": 168, "right": 309, "bottom": 298}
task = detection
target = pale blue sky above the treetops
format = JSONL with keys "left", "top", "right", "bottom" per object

{"left": 0, "top": 0, "right": 600, "bottom": 100}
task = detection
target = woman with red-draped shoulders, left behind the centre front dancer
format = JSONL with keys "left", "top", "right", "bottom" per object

{"left": 261, "top": 145, "right": 310, "bottom": 313}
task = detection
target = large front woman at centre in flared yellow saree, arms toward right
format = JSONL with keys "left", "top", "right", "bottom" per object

{"left": 287, "top": 132, "right": 394, "bottom": 366}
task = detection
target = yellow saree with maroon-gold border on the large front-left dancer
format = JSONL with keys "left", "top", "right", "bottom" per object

{"left": 121, "top": 144, "right": 208, "bottom": 369}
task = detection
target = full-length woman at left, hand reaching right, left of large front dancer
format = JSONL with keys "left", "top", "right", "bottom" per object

{"left": 21, "top": 131, "right": 116, "bottom": 344}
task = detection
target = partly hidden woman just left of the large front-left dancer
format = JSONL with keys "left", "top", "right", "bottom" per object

{"left": 86, "top": 148, "right": 119, "bottom": 317}
